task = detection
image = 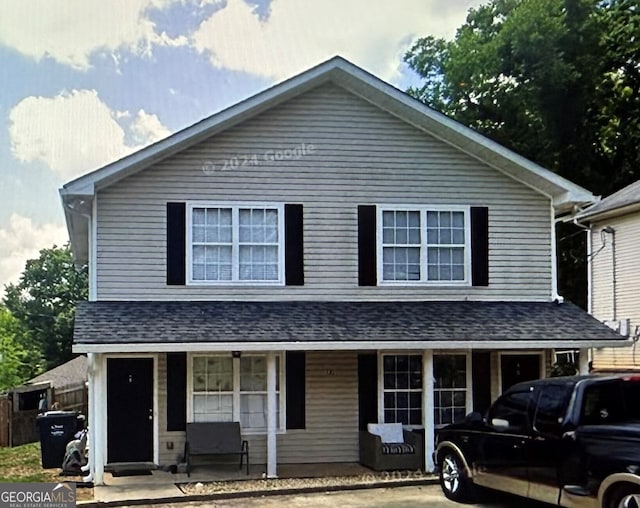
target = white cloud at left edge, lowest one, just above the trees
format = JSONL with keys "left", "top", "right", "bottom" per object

{"left": 0, "top": 213, "right": 68, "bottom": 290}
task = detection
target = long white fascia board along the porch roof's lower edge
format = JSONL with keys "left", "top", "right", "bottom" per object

{"left": 73, "top": 336, "right": 632, "bottom": 353}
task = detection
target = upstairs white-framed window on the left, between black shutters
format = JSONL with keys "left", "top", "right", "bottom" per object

{"left": 187, "top": 203, "right": 284, "bottom": 284}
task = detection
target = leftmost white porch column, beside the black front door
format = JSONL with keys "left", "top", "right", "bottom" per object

{"left": 89, "top": 353, "right": 107, "bottom": 485}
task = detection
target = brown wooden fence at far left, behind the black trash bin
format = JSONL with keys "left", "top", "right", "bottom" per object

{"left": 0, "top": 383, "right": 89, "bottom": 447}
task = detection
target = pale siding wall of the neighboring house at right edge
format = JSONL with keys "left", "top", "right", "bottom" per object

{"left": 591, "top": 213, "right": 640, "bottom": 370}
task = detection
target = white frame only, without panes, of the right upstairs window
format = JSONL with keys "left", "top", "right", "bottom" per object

{"left": 376, "top": 205, "right": 471, "bottom": 286}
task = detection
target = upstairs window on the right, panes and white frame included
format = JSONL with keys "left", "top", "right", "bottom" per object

{"left": 378, "top": 207, "right": 471, "bottom": 284}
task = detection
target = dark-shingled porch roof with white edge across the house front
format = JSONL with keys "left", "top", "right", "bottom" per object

{"left": 74, "top": 301, "right": 629, "bottom": 352}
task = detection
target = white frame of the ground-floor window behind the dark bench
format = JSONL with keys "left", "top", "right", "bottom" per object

{"left": 187, "top": 352, "right": 287, "bottom": 435}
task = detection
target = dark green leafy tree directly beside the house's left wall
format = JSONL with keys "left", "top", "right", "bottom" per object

{"left": 4, "top": 245, "right": 88, "bottom": 369}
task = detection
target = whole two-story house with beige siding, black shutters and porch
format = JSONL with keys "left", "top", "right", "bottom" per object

{"left": 61, "top": 58, "right": 627, "bottom": 483}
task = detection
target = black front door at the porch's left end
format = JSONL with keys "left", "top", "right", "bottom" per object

{"left": 107, "top": 358, "right": 153, "bottom": 463}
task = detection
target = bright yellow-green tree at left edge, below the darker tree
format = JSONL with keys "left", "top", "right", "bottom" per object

{"left": 0, "top": 306, "right": 40, "bottom": 391}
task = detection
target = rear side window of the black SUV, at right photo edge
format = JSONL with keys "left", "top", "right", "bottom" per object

{"left": 580, "top": 379, "right": 640, "bottom": 425}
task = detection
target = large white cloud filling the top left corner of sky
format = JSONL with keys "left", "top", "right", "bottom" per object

{"left": 0, "top": 0, "right": 186, "bottom": 70}
